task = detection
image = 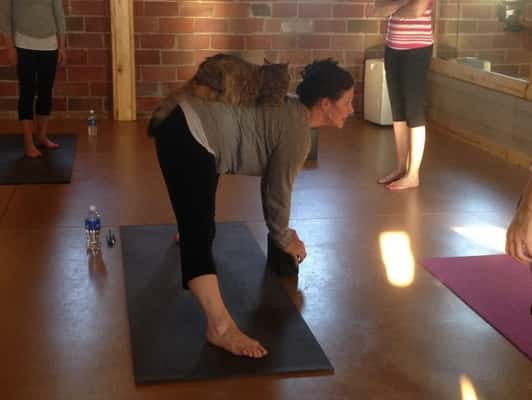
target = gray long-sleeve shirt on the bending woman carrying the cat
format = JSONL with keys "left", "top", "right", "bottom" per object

{"left": 180, "top": 97, "right": 310, "bottom": 248}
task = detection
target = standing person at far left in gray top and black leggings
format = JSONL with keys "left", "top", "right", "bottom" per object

{"left": 0, "top": 0, "right": 66, "bottom": 158}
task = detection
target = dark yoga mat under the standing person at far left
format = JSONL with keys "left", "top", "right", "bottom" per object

{"left": 0, "top": 133, "right": 77, "bottom": 185}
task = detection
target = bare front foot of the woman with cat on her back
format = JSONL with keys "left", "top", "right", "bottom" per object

{"left": 207, "top": 323, "right": 268, "bottom": 358}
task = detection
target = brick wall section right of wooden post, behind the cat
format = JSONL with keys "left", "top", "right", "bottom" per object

{"left": 134, "top": 0, "right": 385, "bottom": 117}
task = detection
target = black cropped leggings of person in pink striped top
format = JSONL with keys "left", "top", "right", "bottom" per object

{"left": 384, "top": 46, "right": 432, "bottom": 128}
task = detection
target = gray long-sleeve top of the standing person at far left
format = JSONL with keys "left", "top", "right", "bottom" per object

{"left": 0, "top": 0, "right": 66, "bottom": 38}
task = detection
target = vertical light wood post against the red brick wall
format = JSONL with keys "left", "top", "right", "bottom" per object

{"left": 110, "top": 0, "right": 137, "bottom": 121}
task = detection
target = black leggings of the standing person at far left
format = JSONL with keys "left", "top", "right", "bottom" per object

{"left": 17, "top": 47, "right": 57, "bottom": 120}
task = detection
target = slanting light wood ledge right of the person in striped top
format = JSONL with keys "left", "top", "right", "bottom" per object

{"left": 430, "top": 58, "right": 529, "bottom": 98}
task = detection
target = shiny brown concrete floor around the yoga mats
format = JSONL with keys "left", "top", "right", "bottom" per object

{"left": 0, "top": 117, "right": 532, "bottom": 400}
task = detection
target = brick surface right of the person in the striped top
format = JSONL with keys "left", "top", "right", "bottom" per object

{"left": 437, "top": 0, "right": 532, "bottom": 79}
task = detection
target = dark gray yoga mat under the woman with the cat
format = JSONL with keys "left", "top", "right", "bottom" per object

{"left": 120, "top": 223, "right": 333, "bottom": 383}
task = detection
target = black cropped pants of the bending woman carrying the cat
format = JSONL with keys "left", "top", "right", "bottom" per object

{"left": 150, "top": 107, "right": 219, "bottom": 289}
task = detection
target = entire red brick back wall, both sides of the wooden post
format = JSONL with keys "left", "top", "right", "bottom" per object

{"left": 0, "top": 0, "right": 386, "bottom": 117}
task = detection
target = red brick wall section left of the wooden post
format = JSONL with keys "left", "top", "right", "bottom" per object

{"left": 0, "top": 0, "right": 112, "bottom": 117}
